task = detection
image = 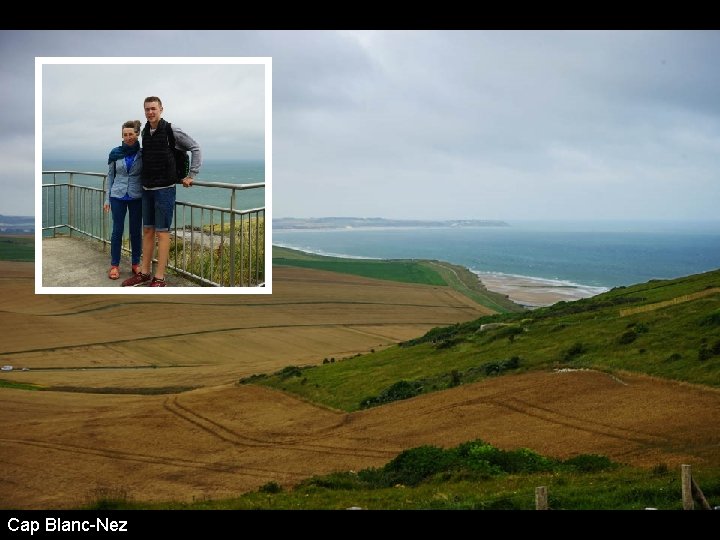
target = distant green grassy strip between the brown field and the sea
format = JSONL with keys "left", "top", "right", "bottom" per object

{"left": 273, "top": 246, "right": 524, "bottom": 313}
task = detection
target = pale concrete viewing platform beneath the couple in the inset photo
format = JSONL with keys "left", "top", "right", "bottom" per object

{"left": 42, "top": 236, "right": 199, "bottom": 287}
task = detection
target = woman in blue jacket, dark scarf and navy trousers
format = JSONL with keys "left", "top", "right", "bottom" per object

{"left": 103, "top": 120, "right": 142, "bottom": 279}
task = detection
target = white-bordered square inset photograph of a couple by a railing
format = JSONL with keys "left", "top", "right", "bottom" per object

{"left": 35, "top": 57, "right": 272, "bottom": 294}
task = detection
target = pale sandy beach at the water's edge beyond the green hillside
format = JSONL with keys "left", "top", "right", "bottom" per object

{"left": 476, "top": 272, "right": 607, "bottom": 307}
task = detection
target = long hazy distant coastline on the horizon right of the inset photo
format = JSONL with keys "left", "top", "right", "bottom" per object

{"left": 273, "top": 217, "right": 510, "bottom": 230}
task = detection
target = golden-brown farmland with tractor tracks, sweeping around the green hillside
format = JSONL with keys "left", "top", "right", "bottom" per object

{"left": 0, "top": 262, "right": 720, "bottom": 508}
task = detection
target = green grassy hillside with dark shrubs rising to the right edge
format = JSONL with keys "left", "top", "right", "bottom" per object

{"left": 249, "top": 270, "right": 720, "bottom": 411}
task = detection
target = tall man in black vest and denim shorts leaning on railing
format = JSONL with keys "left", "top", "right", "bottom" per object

{"left": 122, "top": 96, "right": 202, "bottom": 287}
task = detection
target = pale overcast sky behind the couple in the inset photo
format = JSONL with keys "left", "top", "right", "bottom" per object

{"left": 42, "top": 60, "right": 265, "bottom": 162}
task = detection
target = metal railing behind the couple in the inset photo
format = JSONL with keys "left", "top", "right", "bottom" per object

{"left": 42, "top": 171, "right": 265, "bottom": 287}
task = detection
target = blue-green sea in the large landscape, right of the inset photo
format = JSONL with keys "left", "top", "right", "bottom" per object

{"left": 273, "top": 221, "right": 720, "bottom": 297}
